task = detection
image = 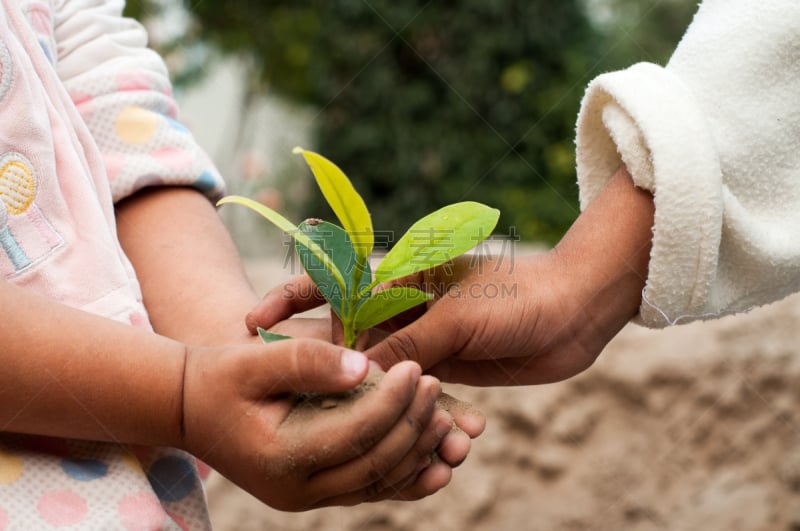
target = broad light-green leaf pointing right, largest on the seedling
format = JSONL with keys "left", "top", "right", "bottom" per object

{"left": 375, "top": 201, "right": 500, "bottom": 282}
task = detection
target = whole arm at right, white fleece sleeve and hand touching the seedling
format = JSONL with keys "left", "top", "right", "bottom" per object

{"left": 251, "top": 0, "right": 800, "bottom": 385}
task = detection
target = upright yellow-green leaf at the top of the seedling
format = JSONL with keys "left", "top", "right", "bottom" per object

{"left": 293, "top": 147, "right": 375, "bottom": 262}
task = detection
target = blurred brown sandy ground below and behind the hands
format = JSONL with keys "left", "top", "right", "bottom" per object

{"left": 208, "top": 258, "right": 800, "bottom": 531}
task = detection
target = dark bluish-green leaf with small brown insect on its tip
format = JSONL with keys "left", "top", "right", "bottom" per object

{"left": 295, "top": 221, "right": 372, "bottom": 318}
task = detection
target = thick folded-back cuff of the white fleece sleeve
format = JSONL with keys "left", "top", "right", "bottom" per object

{"left": 576, "top": 63, "right": 722, "bottom": 328}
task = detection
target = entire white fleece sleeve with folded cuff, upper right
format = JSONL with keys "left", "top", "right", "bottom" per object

{"left": 576, "top": 0, "right": 800, "bottom": 327}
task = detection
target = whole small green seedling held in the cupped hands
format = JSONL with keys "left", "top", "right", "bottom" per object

{"left": 217, "top": 148, "right": 500, "bottom": 348}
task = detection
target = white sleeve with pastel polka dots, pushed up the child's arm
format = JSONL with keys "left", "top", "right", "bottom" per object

{"left": 52, "top": 0, "right": 224, "bottom": 201}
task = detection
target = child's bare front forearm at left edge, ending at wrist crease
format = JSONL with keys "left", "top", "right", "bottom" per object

{"left": 0, "top": 280, "right": 184, "bottom": 445}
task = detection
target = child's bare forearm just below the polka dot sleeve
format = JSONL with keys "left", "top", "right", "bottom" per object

{"left": 117, "top": 188, "right": 258, "bottom": 345}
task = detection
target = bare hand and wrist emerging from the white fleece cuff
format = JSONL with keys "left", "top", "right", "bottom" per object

{"left": 367, "top": 169, "right": 653, "bottom": 385}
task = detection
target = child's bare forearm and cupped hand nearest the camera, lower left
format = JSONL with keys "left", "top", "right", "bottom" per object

{"left": 0, "top": 274, "right": 450, "bottom": 510}
